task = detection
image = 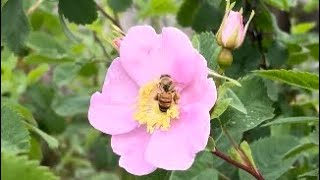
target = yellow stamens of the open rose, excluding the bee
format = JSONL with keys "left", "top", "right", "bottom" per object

{"left": 134, "top": 80, "right": 179, "bottom": 133}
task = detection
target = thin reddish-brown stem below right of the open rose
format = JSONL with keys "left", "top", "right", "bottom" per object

{"left": 211, "top": 148, "right": 264, "bottom": 180}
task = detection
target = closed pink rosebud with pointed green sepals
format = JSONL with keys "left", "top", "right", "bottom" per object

{"left": 216, "top": 0, "right": 254, "bottom": 49}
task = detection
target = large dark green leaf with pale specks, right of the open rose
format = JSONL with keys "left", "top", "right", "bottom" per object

{"left": 219, "top": 76, "right": 274, "bottom": 133}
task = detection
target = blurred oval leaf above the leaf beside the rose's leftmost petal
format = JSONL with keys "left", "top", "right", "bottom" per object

{"left": 53, "top": 63, "right": 81, "bottom": 86}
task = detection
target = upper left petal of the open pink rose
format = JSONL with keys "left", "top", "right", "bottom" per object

{"left": 120, "top": 26, "right": 165, "bottom": 86}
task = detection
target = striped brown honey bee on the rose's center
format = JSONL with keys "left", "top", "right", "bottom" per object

{"left": 154, "top": 74, "right": 179, "bottom": 112}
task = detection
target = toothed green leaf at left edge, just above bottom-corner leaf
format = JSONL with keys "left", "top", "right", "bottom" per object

{"left": 1, "top": 103, "right": 30, "bottom": 153}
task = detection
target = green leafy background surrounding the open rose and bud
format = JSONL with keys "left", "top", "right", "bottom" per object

{"left": 1, "top": 0, "right": 319, "bottom": 180}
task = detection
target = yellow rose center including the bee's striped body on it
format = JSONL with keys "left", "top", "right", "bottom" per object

{"left": 134, "top": 80, "right": 179, "bottom": 133}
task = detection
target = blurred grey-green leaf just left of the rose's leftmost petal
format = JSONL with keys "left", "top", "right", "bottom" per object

{"left": 52, "top": 96, "right": 90, "bottom": 116}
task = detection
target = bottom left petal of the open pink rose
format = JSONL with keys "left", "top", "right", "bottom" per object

{"left": 111, "top": 127, "right": 156, "bottom": 175}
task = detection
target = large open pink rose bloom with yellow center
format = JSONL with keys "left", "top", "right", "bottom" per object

{"left": 88, "top": 26, "right": 217, "bottom": 175}
